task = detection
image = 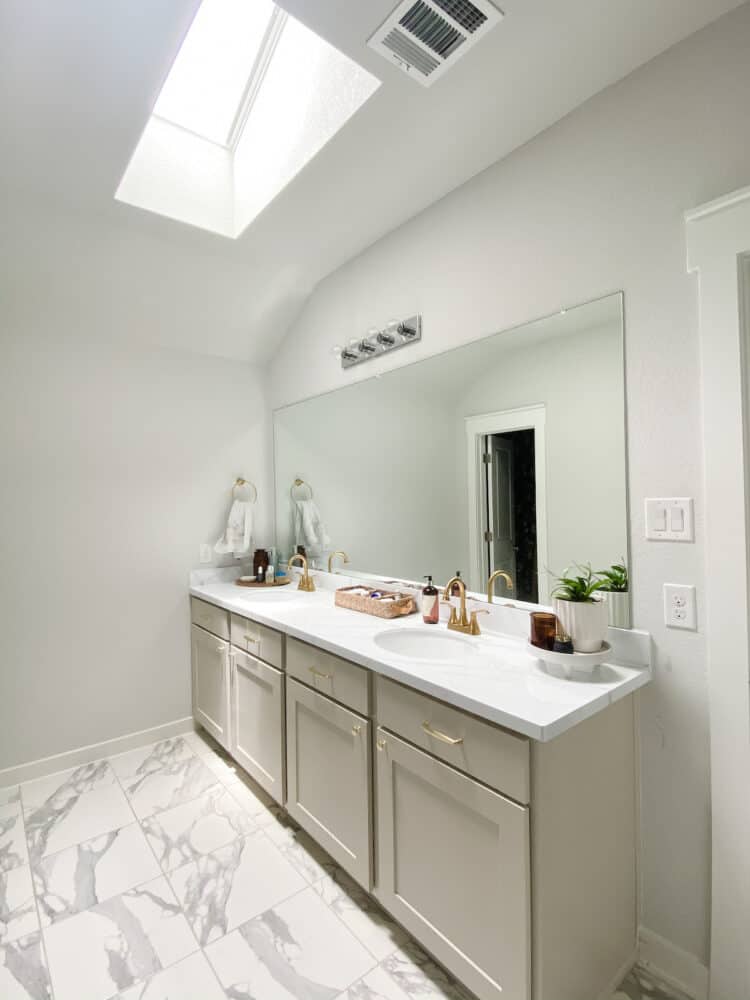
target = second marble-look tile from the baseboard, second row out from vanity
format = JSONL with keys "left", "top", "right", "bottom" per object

{"left": 143, "top": 785, "right": 255, "bottom": 871}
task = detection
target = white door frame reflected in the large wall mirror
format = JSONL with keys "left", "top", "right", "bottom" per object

{"left": 464, "top": 403, "right": 550, "bottom": 604}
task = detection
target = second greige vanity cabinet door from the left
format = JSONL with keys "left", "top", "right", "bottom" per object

{"left": 229, "top": 649, "right": 284, "bottom": 805}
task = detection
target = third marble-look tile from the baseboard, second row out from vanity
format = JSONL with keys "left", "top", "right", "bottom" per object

{"left": 169, "top": 833, "right": 307, "bottom": 945}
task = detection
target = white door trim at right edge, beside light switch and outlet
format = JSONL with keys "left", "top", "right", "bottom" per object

{"left": 685, "top": 188, "right": 750, "bottom": 1000}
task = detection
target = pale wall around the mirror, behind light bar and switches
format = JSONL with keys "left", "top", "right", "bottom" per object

{"left": 273, "top": 5, "right": 750, "bottom": 961}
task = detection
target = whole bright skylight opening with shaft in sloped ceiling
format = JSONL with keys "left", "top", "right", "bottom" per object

{"left": 116, "top": 0, "right": 380, "bottom": 237}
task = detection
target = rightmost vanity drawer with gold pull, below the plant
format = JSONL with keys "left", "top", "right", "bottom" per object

{"left": 375, "top": 676, "right": 529, "bottom": 804}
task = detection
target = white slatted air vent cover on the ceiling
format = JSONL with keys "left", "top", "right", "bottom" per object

{"left": 367, "top": 0, "right": 503, "bottom": 87}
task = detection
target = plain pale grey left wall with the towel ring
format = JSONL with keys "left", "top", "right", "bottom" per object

{"left": 0, "top": 328, "right": 271, "bottom": 769}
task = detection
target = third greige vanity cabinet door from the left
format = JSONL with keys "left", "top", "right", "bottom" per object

{"left": 286, "top": 678, "right": 372, "bottom": 889}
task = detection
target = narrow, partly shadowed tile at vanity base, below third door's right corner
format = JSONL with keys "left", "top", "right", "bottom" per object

{"left": 313, "top": 868, "right": 409, "bottom": 962}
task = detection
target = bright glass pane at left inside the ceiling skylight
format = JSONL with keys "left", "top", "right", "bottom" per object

{"left": 154, "top": 0, "right": 276, "bottom": 145}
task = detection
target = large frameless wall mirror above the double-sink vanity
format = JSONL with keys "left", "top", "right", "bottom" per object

{"left": 274, "top": 294, "right": 628, "bottom": 604}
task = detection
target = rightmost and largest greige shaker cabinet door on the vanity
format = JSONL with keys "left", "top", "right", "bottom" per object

{"left": 376, "top": 729, "right": 530, "bottom": 1000}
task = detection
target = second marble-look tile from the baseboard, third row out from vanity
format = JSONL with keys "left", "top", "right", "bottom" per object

{"left": 34, "top": 823, "right": 161, "bottom": 927}
